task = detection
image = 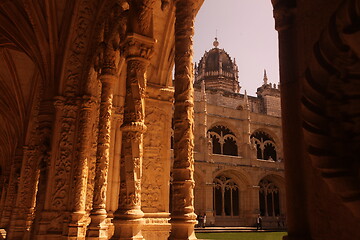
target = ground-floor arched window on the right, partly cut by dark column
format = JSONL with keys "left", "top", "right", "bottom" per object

{"left": 259, "top": 179, "right": 280, "bottom": 217}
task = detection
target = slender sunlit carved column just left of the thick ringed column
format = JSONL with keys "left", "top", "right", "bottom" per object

{"left": 86, "top": 46, "right": 116, "bottom": 239}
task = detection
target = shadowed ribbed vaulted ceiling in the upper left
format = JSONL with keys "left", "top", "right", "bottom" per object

{"left": 0, "top": 0, "right": 82, "bottom": 171}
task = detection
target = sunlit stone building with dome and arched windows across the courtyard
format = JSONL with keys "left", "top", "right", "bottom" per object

{"left": 194, "top": 42, "right": 286, "bottom": 228}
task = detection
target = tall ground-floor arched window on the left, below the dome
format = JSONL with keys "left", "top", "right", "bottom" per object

{"left": 213, "top": 176, "right": 239, "bottom": 216}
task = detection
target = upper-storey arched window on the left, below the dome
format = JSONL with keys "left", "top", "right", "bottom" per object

{"left": 208, "top": 126, "right": 238, "bottom": 156}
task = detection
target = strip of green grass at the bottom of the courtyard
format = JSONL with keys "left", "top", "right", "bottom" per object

{"left": 196, "top": 232, "right": 287, "bottom": 240}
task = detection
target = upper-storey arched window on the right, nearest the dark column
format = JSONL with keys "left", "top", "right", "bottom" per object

{"left": 250, "top": 131, "right": 277, "bottom": 161}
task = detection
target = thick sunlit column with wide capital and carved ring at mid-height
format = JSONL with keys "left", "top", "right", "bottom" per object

{"left": 112, "top": 33, "right": 154, "bottom": 239}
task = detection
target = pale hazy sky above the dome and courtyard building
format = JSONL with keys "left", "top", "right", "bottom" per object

{"left": 194, "top": 0, "right": 279, "bottom": 96}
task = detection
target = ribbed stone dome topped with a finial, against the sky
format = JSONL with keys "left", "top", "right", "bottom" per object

{"left": 194, "top": 38, "right": 240, "bottom": 93}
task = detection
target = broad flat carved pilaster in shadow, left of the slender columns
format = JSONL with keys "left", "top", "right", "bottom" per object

{"left": 34, "top": 96, "right": 79, "bottom": 239}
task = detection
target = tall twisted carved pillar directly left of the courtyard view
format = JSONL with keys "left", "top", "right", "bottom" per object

{"left": 169, "top": 0, "right": 196, "bottom": 240}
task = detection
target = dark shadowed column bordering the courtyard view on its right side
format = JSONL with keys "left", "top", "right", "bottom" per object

{"left": 273, "top": 0, "right": 310, "bottom": 240}
